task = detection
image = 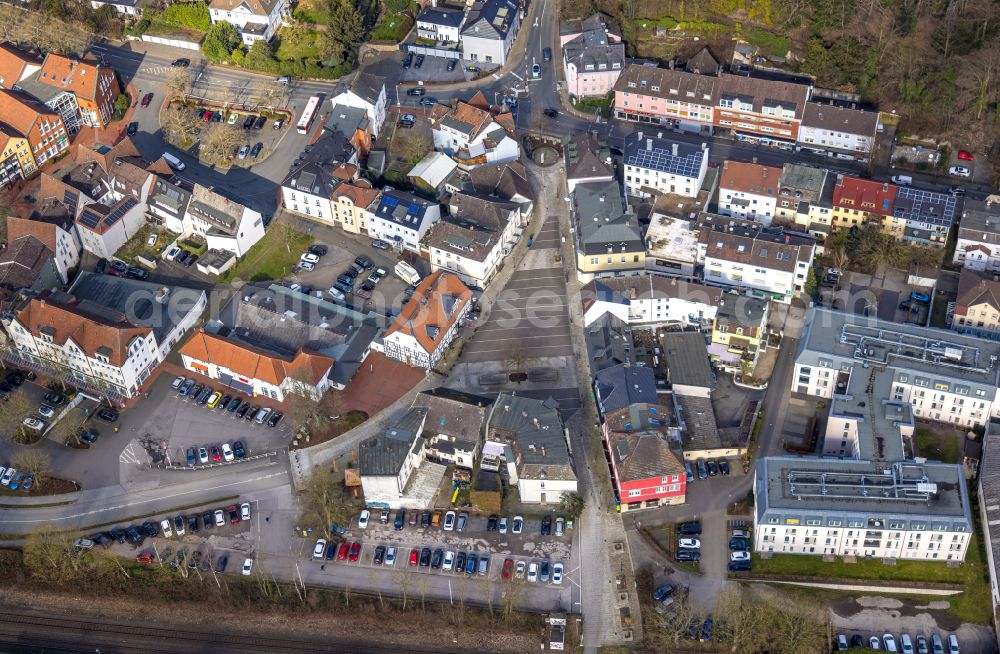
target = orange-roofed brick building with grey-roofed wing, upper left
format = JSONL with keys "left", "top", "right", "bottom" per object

{"left": 13, "top": 53, "right": 121, "bottom": 133}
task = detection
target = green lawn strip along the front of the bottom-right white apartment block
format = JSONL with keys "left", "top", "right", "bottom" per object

{"left": 753, "top": 536, "right": 993, "bottom": 624}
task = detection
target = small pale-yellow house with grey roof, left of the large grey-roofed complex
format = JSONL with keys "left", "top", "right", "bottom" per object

{"left": 708, "top": 293, "right": 768, "bottom": 373}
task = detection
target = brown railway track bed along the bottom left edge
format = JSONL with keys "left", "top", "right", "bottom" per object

{"left": 0, "top": 611, "right": 458, "bottom": 654}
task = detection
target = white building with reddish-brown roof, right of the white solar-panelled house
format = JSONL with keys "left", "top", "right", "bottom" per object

{"left": 719, "top": 160, "right": 783, "bottom": 226}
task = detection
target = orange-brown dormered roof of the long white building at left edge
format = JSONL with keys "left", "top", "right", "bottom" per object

{"left": 17, "top": 294, "right": 153, "bottom": 366}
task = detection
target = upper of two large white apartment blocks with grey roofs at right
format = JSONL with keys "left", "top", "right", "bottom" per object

{"left": 792, "top": 308, "right": 1000, "bottom": 428}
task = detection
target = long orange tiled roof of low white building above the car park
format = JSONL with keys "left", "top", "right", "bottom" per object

{"left": 180, "top": 329, "right": 333, "bottom": 386}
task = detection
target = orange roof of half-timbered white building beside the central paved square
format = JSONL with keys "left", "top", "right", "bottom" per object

{"left": 385, "top": 270, "right": 472, "bottom": 352}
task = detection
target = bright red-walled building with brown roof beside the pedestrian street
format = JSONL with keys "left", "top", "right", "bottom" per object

{"left": 606, "top": 432, "right": 687, "bottom": 512}
